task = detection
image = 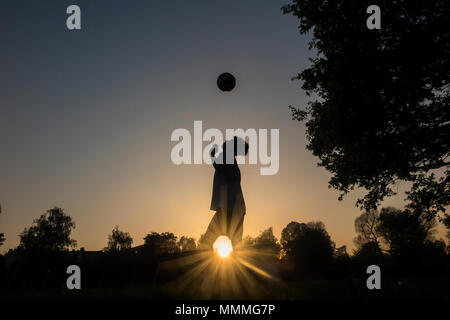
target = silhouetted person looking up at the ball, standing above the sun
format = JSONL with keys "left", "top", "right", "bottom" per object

{"left": 204, "top": 137, "right": 249, "bottom": 248}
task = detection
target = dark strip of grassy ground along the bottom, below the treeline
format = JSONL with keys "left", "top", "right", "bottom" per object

{"left": 0, "top": 278, "right": 450, "bottom": 300}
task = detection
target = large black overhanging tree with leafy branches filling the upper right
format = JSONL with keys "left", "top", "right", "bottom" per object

{"left": 282, "top": 0, "right": 450, "bottom": 215}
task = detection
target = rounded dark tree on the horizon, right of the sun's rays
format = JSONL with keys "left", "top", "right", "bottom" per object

{"left": 281, "top": 221, "right": 335, "bottom": 273}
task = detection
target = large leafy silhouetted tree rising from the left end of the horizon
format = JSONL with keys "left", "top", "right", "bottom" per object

{"left": 19, "top": 207, "right": 77, "bottom": 251}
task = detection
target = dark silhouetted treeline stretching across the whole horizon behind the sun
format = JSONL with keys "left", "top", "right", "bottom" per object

{"left": 0, "top": 207, "right": 450, "bottom": 299}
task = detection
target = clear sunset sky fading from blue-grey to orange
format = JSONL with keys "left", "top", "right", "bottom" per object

{"left": 0, "top": 0, "right": 438, "bottom": 252}
